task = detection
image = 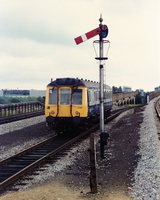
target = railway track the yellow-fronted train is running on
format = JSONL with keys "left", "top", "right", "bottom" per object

{"left": 0, "top": 109, "right": 135, "bottom": 191}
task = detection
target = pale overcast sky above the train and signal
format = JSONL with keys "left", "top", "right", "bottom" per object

{"left": 0, "top": 0, "right": 160, "bottom": 91}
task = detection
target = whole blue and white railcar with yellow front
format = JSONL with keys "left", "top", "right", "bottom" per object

{"left": 45, "top": 78, "right": 112, "bottom": 133}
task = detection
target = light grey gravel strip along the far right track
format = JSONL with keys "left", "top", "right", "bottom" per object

{"left": 131, "top": 99, "right": 160, "bottom": 200}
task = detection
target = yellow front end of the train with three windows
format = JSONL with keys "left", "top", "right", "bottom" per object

{"left": 45, "top": 78, "right": 88, "bottom": 133}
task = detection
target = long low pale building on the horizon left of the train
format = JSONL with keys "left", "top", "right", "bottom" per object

{"left": 0, "top": 89, "right": 45, "bottom": 97}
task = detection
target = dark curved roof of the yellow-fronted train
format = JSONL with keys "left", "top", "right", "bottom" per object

{"left": 47, "top": 78, "right": 110, "bottom": 88}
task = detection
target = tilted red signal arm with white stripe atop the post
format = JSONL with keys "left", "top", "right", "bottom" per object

{"left": 74, "top": 27, "right": 101, "bottom": 44}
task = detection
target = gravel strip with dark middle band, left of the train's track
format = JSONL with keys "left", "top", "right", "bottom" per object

{"left": 0, "top": 116, "right": 53, "bottom": 161}
